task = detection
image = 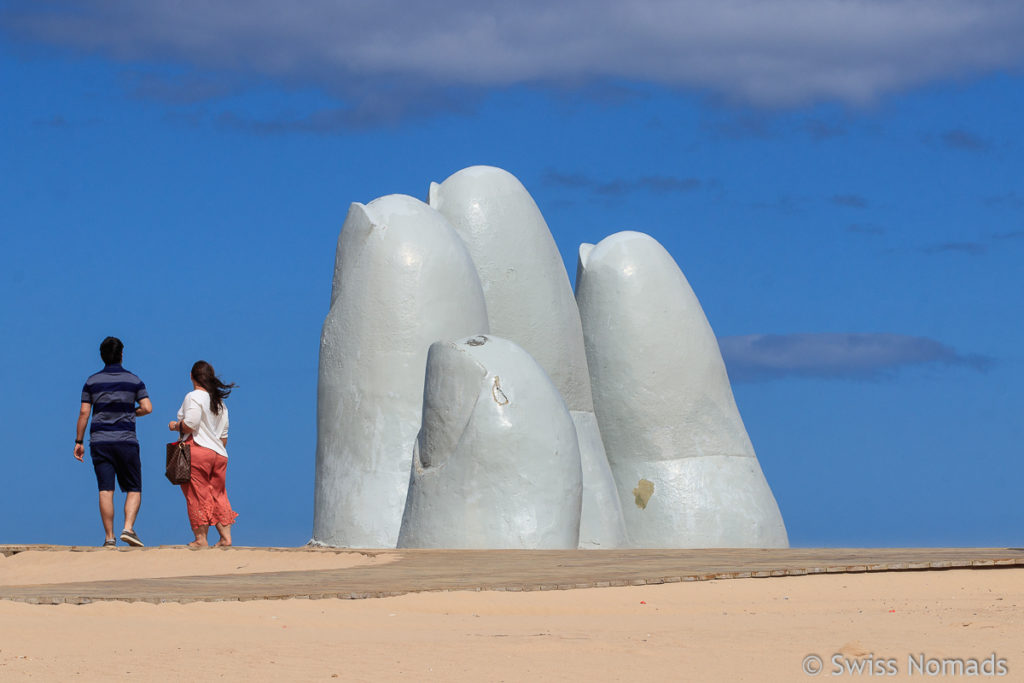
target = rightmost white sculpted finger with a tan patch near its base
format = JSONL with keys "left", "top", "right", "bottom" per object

{"left": 577, "top": 231, "right": 788, "bottom": 548}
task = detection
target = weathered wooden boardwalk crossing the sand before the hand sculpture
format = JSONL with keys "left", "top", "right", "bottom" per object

{"left": 0, "top": 546, "right": 1024, "bottom": 604}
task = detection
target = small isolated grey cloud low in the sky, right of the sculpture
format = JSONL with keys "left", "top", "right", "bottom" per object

{"left": 718, "top": 334, "right": 991, "bottom": 382}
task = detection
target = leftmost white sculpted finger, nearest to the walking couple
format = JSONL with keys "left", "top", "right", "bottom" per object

{"left": 313, "top": 195, "right": 488, "bottom": 548}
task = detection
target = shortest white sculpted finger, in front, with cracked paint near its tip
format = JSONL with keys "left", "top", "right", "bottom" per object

{"left": 398, "top": 335, "right": 583, "bottom": 549}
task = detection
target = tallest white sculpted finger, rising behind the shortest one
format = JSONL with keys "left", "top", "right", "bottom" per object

{"left": 429, "top": 166, "right": 628, "bottom": 548}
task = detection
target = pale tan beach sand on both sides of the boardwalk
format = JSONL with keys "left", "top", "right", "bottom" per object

{"left": 0, "top": 549, "right": 1024, "bottom": 681}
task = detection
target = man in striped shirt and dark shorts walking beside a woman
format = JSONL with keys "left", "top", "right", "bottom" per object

{"left": 75, "top": 337, "right": 153, "bottom": 547}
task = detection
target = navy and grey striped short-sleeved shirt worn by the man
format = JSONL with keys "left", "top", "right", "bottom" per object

{"left": 82, "top": 364, "right": 150, "bottom": 443}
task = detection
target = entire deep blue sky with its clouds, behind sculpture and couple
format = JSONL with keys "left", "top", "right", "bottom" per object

{"left": 0, "top": 0, "right": 1024, "bottom": 546}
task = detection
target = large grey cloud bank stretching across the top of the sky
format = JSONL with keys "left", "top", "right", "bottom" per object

{"left": 8, "top": 0, "right": 1024, "bottom": 106}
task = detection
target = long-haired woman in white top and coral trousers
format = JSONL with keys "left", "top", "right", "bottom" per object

{"left": 167, "top": 360, "right": 239, "bottom": 548}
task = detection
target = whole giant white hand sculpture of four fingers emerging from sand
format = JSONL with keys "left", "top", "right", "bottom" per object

{"left": 313, "top": 166, "right": 787, "bottom": 549}
